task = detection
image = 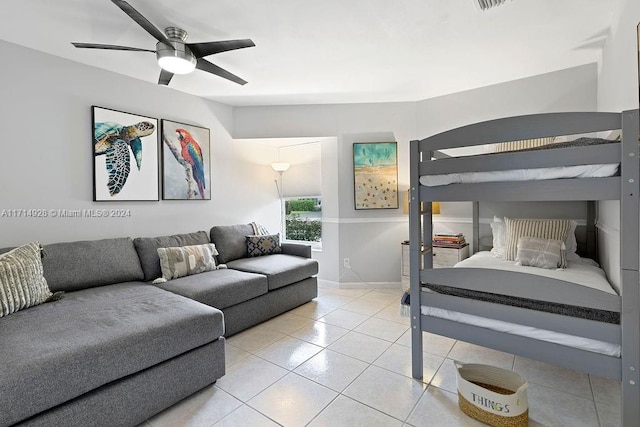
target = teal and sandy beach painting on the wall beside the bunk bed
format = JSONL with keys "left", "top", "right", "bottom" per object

{"left": 353, "top": 142, "right": 398, "bottom": 210}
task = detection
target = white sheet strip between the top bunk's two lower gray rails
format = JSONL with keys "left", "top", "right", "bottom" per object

{"left": 420, "top": 163, "right": 619, "bottom": 187}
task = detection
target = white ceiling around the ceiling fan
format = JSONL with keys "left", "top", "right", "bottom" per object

{"left": 0, "top": 0, "right": 620, "bottom": 106}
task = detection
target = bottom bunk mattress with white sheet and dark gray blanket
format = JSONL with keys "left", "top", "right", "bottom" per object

{"left": 421, "top": 252, "right": 620, "bottom": 357}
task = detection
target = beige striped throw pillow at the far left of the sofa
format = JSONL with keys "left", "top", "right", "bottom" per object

{"left": 0, "top": 242, "right": 52, "bottom": 317}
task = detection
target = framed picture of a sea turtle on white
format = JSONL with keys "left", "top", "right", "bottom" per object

{"left": 91, "top": 106, "right": 160, "bottom": 202}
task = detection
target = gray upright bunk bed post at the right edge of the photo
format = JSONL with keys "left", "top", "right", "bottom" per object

{"left": 620, "top": 110, "right": 640, "bottom": 426}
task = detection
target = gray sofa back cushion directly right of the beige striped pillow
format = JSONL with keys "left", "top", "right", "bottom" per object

{"left": 42, "top": 237, "right": 142, "bottom": 292}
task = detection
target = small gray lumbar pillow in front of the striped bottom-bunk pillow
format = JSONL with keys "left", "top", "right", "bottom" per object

{"left": 516, "top": 237, "right": 567, "bottom": 269}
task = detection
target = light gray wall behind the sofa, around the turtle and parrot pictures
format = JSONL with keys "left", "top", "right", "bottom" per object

{"left": 0, "top": 41, "right": 278, "bottom": 247}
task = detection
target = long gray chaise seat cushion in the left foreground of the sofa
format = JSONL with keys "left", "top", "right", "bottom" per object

{"left": 0, "top": 282, "right": 224, "bottom": 425}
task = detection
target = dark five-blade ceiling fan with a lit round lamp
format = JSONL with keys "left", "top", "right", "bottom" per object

{"left": 71, "top": 0, "right": 255, "bottom": 86}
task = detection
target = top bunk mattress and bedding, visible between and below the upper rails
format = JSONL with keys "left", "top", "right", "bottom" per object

{"left": 420, "top": 138, "right": 620, "bottom": 187}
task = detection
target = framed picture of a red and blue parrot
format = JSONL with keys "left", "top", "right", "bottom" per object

{"left": 162, "top": 119, "right": 211, "bottom": 200}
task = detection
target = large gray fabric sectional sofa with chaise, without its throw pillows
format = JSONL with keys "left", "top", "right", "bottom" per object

{"left": 0, "top": 225, "right": 318, "bottom": 427}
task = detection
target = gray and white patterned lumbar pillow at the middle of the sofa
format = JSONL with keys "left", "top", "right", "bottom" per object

{"left": 154, "top": 243, "right": 218, "bottom": 283}
